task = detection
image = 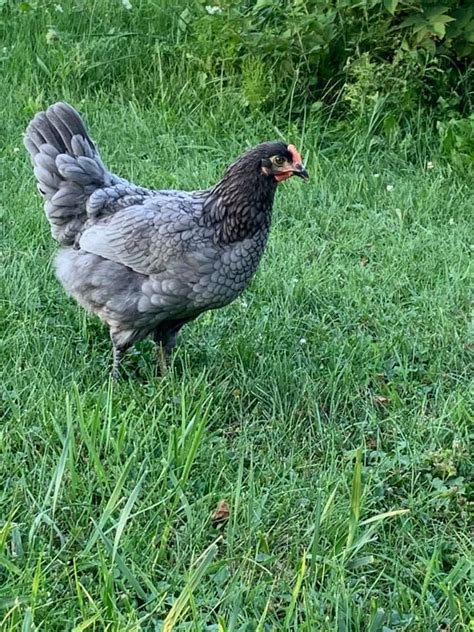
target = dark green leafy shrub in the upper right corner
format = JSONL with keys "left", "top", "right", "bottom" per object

{"left": 186, "top": 0, "right": 474, "bottom": 111}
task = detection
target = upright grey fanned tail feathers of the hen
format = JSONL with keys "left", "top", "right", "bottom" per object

{"left": 24, "top": 102, "right": 116, "bottom": 246}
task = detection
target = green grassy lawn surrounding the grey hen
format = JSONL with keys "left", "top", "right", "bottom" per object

{"left": 0, "top": 2, "right": 474, "bottom": 632}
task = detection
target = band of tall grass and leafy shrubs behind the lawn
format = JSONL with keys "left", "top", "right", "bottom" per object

{"left": 0, "top": 0, "right": 474, "bottom": 119}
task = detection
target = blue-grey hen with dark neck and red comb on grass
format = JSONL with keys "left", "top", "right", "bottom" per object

{"left": 24, "top": 102, "right": 308, "bottom": 377}
